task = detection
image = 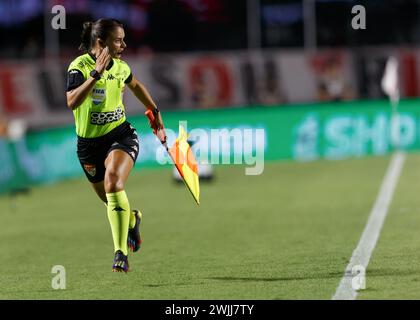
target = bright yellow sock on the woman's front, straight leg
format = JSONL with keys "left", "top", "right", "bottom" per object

{"left": 106, "top": 190, "right": 131, "bottom": 255}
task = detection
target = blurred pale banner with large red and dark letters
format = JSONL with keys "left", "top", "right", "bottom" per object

{"left": 0, "top": 47, "right": 420, "bottom": 128}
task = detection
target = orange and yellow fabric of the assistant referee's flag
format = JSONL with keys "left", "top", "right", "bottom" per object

{"left": 168, "top": 125, "right": 200, "bottom": 204}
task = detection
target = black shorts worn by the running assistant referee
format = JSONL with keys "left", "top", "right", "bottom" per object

{"left": 77, "top": 121, "right": 139, "bottom": 183}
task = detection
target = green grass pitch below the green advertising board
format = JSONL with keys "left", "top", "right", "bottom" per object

{"left": 0, "top": 154, "right": 420, "bottom": 300}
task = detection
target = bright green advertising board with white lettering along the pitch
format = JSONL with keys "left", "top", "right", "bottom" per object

{"left": 0, "top": 100, "right": 420, "bottom": 192}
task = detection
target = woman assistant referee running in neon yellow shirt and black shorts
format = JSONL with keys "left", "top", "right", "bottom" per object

{"left": 67, "top": 19, "right": 166, "bottom": 272}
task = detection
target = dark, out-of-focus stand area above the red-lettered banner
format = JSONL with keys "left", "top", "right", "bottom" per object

{"left": 0, "top": 0, "right": 420, "bottom": 58}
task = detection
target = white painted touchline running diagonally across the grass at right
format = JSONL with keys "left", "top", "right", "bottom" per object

{"left": 332, "top": 152, "right": 405, "bottom": 300}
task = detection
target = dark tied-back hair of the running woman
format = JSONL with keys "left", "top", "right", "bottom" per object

{"left": 79, "top": 19, "right": 124, "bottom": 52}
